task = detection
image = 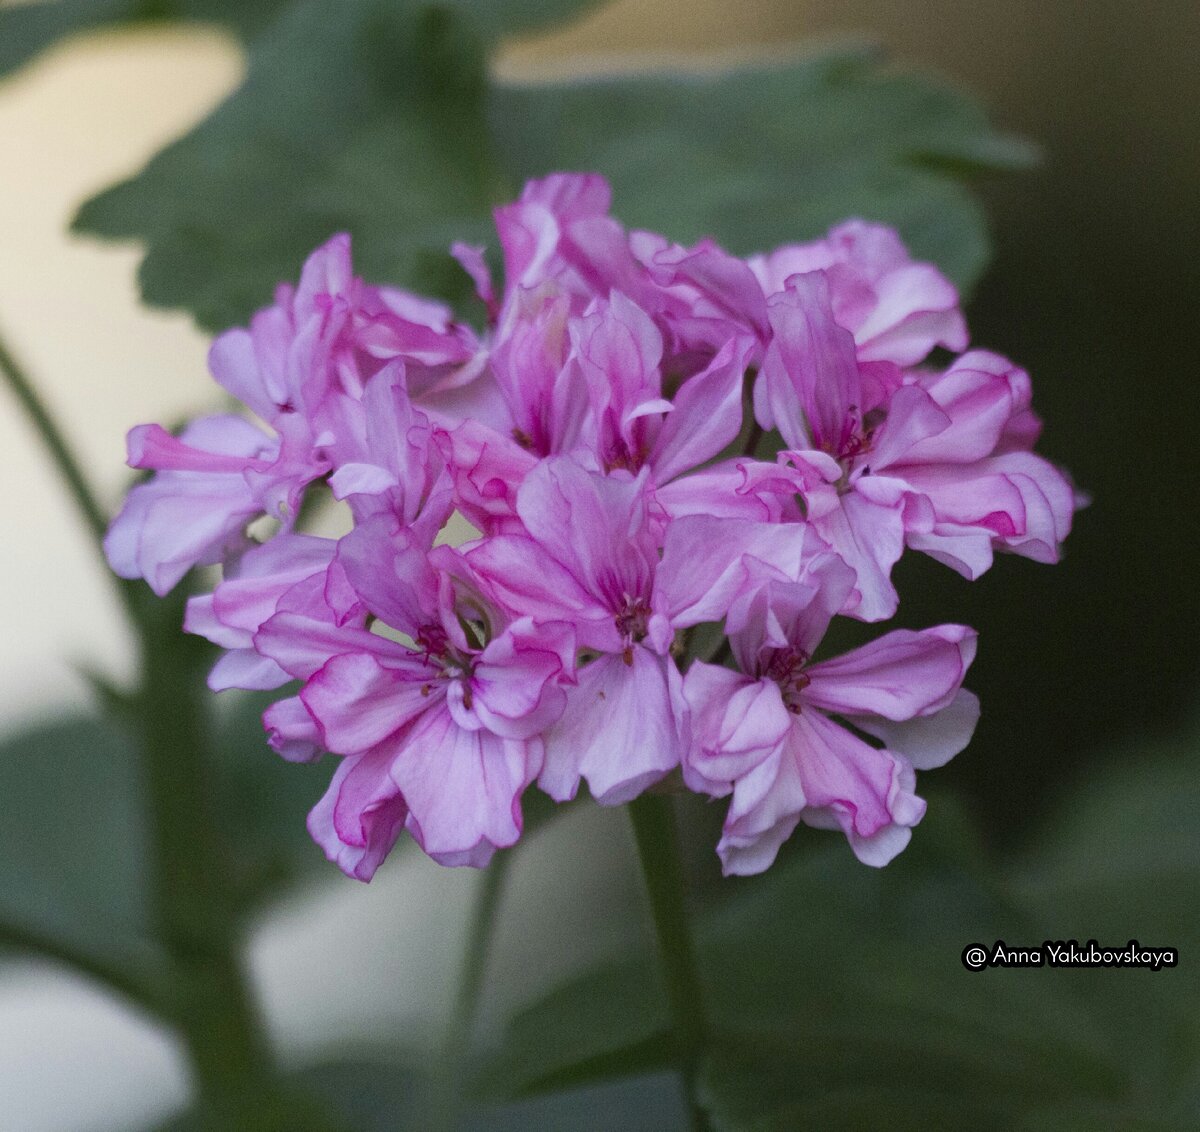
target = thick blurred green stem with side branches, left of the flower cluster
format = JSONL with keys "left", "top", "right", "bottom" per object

{"left": 0, "top": 324, "right": 323, "bottom": 1132}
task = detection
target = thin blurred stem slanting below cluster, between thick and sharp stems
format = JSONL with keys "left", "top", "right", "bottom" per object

{"left": 432, "top": 850, "right": 512, "bottom": 1130}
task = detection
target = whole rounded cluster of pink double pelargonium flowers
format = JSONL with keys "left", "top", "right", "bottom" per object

{"left": 106, "top": 174, "right": 1076, "bottom": 880}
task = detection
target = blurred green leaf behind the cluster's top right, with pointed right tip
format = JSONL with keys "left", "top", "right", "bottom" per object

{"left": 492, "top": 49, "right": 1031, "bottom": 286}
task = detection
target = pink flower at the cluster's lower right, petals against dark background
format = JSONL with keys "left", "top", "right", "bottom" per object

{"left": 683, "top": 559, "right": 978, "bottom": 874}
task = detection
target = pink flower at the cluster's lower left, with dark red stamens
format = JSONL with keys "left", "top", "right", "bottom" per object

{"left": 254, "top": 517, "right": 575, "bottom": 880}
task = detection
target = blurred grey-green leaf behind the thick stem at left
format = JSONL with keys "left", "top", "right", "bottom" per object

{"left": 0, "top": 696, "right": 329, "bottom": 996}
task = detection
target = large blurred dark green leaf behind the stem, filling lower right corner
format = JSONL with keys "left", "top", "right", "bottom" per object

{"left": 481, "top": 744, "right": 1200, "bottom": 1130}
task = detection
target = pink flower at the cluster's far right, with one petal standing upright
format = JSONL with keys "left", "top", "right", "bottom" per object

{"left": 755, "top": 272, "right": 1075, "bottom": 621}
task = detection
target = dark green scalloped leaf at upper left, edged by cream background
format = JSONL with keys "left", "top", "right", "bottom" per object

{"left": 76, "top": 0, "right": 493, "bottom": 327}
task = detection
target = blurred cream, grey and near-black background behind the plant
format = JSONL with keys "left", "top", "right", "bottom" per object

{"left": 0, "top": 0, "right": 1200, "bottom": 1132}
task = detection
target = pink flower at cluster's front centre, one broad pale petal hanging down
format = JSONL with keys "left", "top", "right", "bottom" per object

{"left": 467, "top": 457, "right": 824, "bottom": 804}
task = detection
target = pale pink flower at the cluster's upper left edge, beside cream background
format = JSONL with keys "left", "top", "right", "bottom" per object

{"left": 104, "top": 235, "right": 480, "bottom": 594}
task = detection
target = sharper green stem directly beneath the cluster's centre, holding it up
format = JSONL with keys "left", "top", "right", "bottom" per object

{"left": 629, "top": 792, "right": 709, "bottom": 1132}
